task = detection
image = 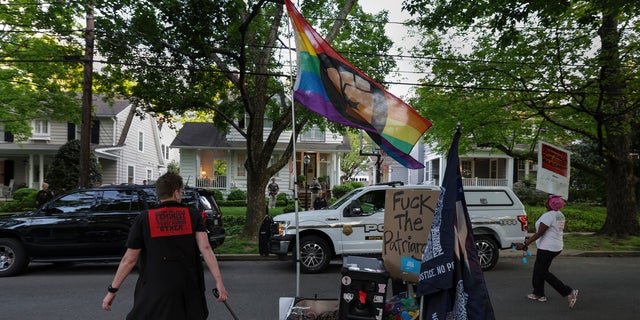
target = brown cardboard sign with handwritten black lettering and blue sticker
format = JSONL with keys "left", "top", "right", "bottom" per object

{"left": 382, "top": 188, "right": 440, "bottom": 283}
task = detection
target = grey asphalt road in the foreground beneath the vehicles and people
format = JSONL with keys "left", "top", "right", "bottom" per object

{"left": 0, "top": 256, "right": 640, "bottom": 320}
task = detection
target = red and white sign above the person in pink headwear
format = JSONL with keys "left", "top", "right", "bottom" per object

{"left": 536, "top": 141, "right": 571, "bottom": 199}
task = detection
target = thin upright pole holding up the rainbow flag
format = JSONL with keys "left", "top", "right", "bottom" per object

{"left": 287, "top": 8, "right": 300, "bottom": 298}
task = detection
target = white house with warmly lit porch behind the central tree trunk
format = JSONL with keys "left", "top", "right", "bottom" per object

{"left": 171, "top": 122, "right": 351, "bottom": 198}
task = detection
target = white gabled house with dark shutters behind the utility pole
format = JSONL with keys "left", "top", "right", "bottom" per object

{"left": 0, "top": 97, "right": 179, "bottom": 197}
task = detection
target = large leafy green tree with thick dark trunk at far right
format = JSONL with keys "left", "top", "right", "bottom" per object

{"left": 403, "top": 0, "right": 640, "bottom": 236}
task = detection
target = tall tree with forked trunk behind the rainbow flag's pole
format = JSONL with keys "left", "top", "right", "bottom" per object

{"left": 96, "top": 0, "right": 394, "bottom": 236}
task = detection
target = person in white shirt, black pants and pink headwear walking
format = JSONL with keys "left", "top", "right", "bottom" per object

{"left": 516, "top": 195, "right": 578, "bottom": 308}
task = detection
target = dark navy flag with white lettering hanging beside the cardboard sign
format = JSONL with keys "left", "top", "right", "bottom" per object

{"left": 417, "top": 129, "right": 495, "bottom": 320}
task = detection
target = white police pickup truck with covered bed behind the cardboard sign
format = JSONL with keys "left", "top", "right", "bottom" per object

{"left": 270, "top": 183, "right": 527, "bottom": 273}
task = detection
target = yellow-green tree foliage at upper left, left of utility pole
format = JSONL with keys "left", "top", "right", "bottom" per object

{"left": 0, "top": 0, "right": 83, "bottom": 142}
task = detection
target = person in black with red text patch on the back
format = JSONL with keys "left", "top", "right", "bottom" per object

{"left": 102, "top": 172, "right": 228, "bottom": 320}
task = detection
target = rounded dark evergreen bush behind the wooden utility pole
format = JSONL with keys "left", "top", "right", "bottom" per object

{"left": 45, "top": 140, "right": 102, "bottom": 194}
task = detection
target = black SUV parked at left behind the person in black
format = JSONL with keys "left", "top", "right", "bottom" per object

{"left": 0, "top": 185, "right": 225, "bottom": 277}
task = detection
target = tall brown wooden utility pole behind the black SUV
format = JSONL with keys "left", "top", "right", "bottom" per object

{"left": 78, "top": 1, "right": 95, "bottom": 188}
